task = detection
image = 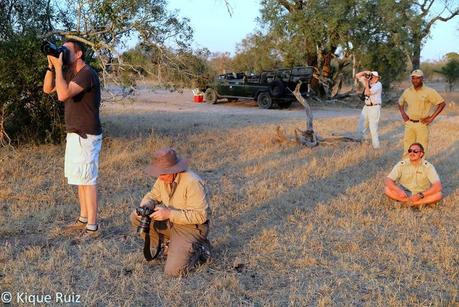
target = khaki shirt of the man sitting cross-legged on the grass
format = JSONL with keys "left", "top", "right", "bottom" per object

{"left": 387, "top": 159, "right": 440, "bottom": 194}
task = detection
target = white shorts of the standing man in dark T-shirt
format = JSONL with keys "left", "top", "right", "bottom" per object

{"left": 64, "top": 133, "right": 102, "bottom": 185}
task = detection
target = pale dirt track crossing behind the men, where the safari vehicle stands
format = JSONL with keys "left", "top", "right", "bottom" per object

{"left": 102, "top": 88, "right": 459, "bottom": 131}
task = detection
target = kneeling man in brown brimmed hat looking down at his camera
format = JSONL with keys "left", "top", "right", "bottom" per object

{"left": 130, "top": 148, "right": 210, "bottom": 277}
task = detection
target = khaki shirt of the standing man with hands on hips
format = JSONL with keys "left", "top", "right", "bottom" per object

{"left": 398, "top": 85, "right": 444, "bottom": 120}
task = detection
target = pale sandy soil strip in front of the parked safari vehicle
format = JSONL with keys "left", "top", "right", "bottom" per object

{"left": 102, "top": 83, "right": 458, "bottom": 122}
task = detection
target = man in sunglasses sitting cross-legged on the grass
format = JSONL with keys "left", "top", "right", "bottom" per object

{"left": 384, "top": 143, "right": 443, "bottom": 207}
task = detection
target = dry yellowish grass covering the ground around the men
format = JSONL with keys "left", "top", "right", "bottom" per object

{"left": 0, "top": 91, "right": 459, "bottom": 306}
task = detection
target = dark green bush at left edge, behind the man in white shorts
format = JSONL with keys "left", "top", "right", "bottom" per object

{"left": 0, "top": 0, "right": 63, "bottom": 143}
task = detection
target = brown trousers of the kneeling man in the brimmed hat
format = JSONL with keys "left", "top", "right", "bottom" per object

{"left": 130, "top": 211, "right": 209, "bottom": 276}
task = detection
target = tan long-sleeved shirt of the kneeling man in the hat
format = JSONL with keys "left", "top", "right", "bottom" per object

{"left": 142, "top": 171, "right": 210, "bottom": 225}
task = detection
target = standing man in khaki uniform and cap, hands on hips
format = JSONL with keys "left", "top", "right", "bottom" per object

{"left": 398, "top": 69, "right": 445, "bottom": 155}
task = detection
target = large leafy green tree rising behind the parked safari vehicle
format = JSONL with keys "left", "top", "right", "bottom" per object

{"left": 252, "top": 0, "right": 418, "bottom": 92}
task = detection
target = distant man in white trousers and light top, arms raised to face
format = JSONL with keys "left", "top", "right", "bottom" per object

{"left": 355, "top": 71, "right": 382, "bottom": 149}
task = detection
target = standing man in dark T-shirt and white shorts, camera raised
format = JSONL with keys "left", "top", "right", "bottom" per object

{"left": 43, "top": 40, "right": 102, "bottom": 238}
